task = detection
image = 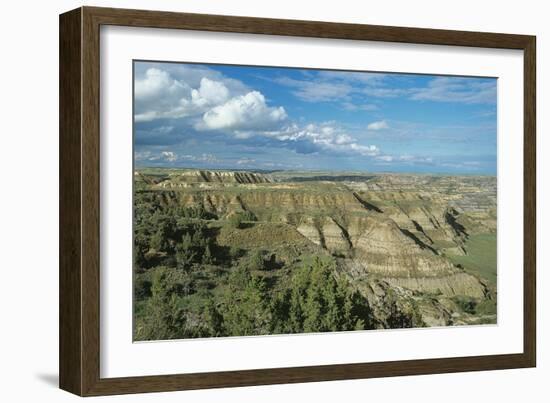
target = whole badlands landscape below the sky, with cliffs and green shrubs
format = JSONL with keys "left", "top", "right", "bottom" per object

{"left": 134, "top": 168, "right": 497, "bottom": 340}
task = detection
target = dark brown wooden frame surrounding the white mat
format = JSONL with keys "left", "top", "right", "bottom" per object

{"left": 59, "top": 7, "right": 536, "bottom": 396}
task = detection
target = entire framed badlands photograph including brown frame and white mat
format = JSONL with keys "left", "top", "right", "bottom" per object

{"left": 60, "top": 7, "right": 536, "bottom": 396}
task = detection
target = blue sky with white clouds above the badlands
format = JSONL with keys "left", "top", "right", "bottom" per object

{"left": 134, "top": 61, "right": 497, "bottom": 175}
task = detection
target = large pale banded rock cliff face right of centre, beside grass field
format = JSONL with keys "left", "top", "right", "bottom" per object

{"left": 298, "top": 216, "right": 487, "bottom": 298}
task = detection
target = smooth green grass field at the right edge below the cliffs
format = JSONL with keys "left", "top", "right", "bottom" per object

{"left": 449, "top": 234, "right": 497, "bottom": 286}
